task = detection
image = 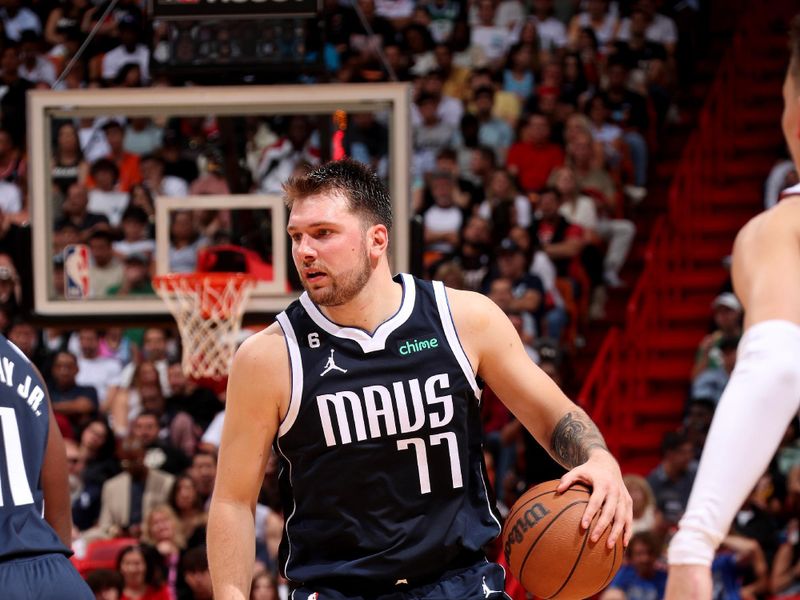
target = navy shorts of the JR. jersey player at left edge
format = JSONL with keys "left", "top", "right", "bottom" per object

{"left": 0, "top": 554, "right": 94, "bottom": 600}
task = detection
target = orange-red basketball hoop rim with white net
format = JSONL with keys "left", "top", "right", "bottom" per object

{"left": 153, "top": 273, "right": 256, "bottom": 379}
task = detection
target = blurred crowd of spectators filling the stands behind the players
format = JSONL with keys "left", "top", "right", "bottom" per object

{"left": 0, "top": 0, "right": 736, "bottom": 600}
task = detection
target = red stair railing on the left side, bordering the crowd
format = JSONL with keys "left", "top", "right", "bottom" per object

{"left": 578, "top": 5, "right": 768, "bottom": 450}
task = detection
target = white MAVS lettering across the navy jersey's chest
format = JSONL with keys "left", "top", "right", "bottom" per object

{"left": 317, "top": 373, "right": 453, "bottom": 446}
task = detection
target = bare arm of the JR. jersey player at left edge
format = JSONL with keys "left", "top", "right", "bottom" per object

{"left": 40, "top": 380, "right": 72, "bottom": 548}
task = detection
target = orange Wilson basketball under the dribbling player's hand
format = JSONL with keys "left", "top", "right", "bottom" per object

{"left": 503, "top": 479, "right": 624, "bottom": 600}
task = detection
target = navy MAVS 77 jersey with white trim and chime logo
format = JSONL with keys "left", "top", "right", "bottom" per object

{"left": 276, "top": 274, "right": 500, "bottom": 585}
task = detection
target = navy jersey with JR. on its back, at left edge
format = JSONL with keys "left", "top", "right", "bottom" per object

{"left": 0, "top": 335, "right": 70, "bottom": 560}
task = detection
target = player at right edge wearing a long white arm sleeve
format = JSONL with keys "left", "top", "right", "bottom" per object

{"left": 666, "top": 15, "right": 800, "bottom": 600}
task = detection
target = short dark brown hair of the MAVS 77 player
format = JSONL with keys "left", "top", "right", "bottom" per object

{"left": 283, "top": 158, "right": 392, "bottom": 230}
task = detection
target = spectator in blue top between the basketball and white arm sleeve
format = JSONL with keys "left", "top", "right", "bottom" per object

{"left": 600, "top": 531, "right": 667, "bottom": 600}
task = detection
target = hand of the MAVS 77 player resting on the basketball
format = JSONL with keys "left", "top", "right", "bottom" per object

{"left": 558, "top": 449, "right": 633, "bottom": 548}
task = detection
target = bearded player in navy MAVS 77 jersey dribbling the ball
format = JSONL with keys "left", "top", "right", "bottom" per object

{"left": 208, "top": 160, "right": 632, "bottom": 600}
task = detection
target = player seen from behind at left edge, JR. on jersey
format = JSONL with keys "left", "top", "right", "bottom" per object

{"left": 0, "top": 335, "right": 94, "bottom": 600}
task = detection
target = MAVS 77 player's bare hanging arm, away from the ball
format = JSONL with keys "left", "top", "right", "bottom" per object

{"left": 208, "top": 324, "right": 291, "bottom": 600}
